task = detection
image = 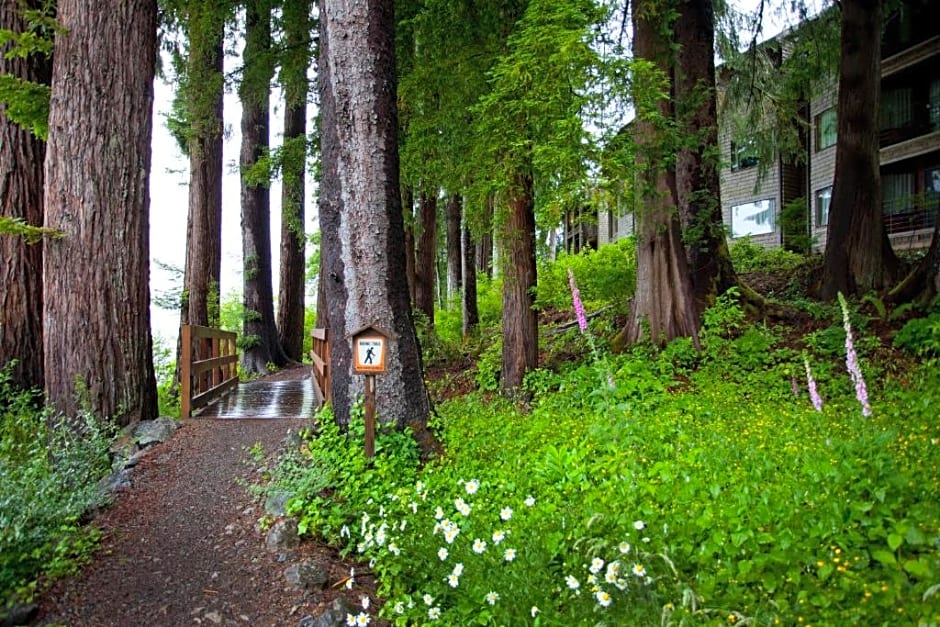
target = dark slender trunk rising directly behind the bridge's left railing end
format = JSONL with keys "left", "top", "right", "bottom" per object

{"left": 239, "top": 0, "right": 287, "bottom": 374}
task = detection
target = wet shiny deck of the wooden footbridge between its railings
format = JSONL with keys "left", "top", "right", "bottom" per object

{"left": 199, "top": 378, "right": 317, "bottom": 419}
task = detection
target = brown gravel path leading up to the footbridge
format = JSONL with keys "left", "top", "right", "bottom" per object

{"left": 39, "top": 419, "right": 309, "bottom": 626}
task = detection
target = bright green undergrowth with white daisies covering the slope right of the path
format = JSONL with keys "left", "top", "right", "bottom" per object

{"left": 280, "top": 300, "right": 940, "bottom": 625}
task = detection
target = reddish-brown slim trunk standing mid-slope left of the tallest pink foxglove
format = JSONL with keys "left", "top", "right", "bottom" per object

{"left": 499, "top": 173, "right": 539, "bottom": 394}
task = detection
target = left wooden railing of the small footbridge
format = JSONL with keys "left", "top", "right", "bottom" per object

{"left": 180, "top": 324, "right": 238, "bottom": 418}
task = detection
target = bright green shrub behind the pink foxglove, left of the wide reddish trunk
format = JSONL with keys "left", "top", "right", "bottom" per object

{"left": 536, "top": 238, "right": 636, "bottom": 311}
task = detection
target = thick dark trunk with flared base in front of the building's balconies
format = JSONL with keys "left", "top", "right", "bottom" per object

{"left": 821, "top": 0, "right": 898, "bottom": 299}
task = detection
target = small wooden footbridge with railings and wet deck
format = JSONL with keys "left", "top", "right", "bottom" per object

{"left": 180, "top": 325, "right": 330, "bottom": 418}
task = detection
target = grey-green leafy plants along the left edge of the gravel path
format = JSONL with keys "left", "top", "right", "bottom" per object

{"left": 0, "top": 367, "right": 111, "bottom": 605}
